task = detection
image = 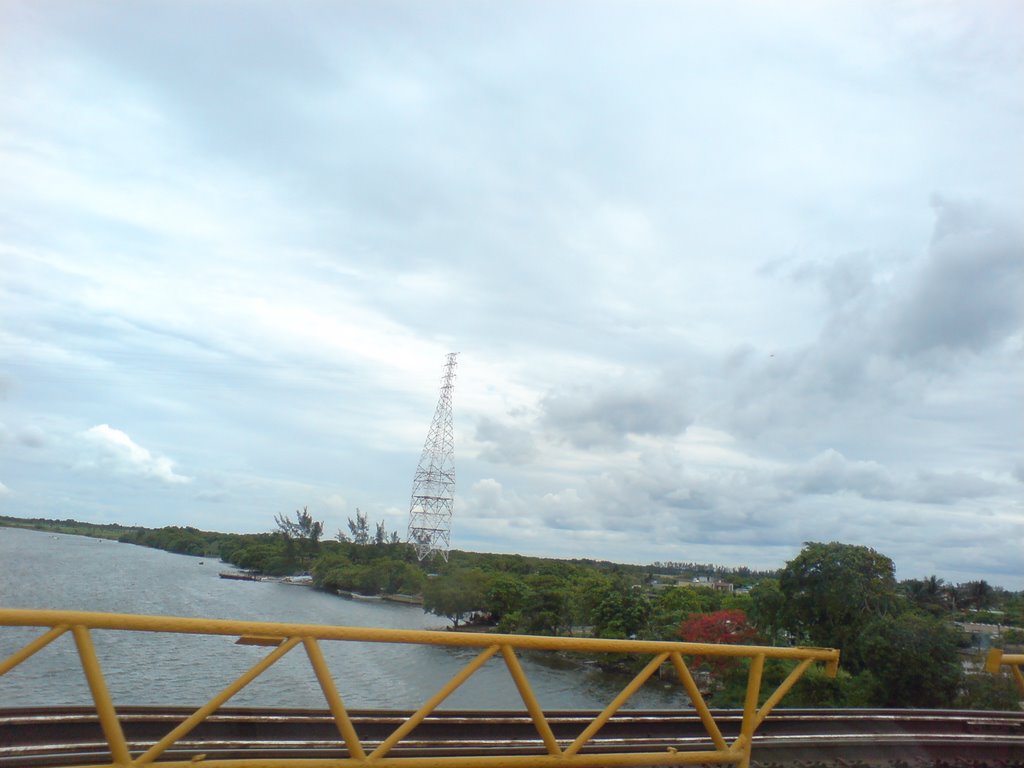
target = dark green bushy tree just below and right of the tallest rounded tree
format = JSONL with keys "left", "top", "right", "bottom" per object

{"left": 858, "top": 612, "right": 964, "bottom": 708}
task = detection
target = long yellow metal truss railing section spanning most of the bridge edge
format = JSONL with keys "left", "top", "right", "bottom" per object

{"left": 0, "top": 609, "right": 839, "bottom": 768}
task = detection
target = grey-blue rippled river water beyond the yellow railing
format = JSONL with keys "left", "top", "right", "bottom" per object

{"left": 0, "top": 527, "right": 688, "bottom": 710}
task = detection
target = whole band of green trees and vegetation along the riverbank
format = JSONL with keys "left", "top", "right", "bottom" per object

{"left": 0, "top": 509, "right": 1024, "bottom": 709}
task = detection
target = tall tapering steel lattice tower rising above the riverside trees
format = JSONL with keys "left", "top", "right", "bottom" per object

{"left": 408, "top": 352, "right": 459, "bottom": 562}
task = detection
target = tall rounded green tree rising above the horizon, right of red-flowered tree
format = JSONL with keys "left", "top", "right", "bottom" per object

{"left": 778, "top": 542, "right": 897, "bottom": 672}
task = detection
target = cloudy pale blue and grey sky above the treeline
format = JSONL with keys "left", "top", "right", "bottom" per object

{"left": 0, "top": 0, "right": 1024, "bottom": 589}
